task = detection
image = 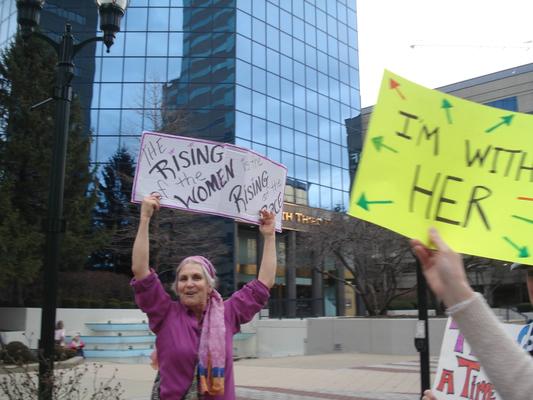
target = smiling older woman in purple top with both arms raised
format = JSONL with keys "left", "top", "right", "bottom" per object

{"left": 132, "top": 195, "right": 276, "bottom": 400}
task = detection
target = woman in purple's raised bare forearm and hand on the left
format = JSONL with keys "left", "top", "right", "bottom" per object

{"left": 131, "top": 194, "right": 160, "bottom": 280}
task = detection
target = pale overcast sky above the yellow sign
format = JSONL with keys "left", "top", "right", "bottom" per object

{"left": 357, "top": 0, "right": 533, "bottom": 107}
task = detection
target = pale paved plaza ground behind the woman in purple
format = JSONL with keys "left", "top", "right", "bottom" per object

{"left": 88, "top": 353, "right": 437, "bottom": 400}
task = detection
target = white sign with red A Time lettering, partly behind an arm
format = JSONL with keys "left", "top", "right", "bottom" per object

{"left": 432, "top": 318, "right": 533, "bottom": 400}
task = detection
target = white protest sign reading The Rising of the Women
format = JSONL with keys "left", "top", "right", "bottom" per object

{"left": 132, "top": 132, "right": 287, "bottom": 231}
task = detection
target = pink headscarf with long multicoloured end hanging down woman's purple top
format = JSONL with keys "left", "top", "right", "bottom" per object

{"left": 181, "top": 256, "right": 226, "bottom": 396}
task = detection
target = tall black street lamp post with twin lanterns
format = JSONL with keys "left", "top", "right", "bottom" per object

{"left": 17, "top": 0, "right": 128, "bottom": 400}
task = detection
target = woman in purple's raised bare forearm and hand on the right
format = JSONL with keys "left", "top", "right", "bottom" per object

{"left": 257, "top": 210, "right": 277, "bottom": 288}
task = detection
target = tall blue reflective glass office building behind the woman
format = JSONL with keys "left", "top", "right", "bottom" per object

{"left": 0, "top": 0, "right": 360, "bottom": 318}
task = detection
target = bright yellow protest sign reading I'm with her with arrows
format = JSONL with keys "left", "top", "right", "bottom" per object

{"left": 348, "top": 71, "right": 533, "bottom": 265}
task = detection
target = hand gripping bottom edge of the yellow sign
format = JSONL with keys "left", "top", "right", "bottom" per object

{"left": 411, "top": 228, "right": 474, "bottom": 307}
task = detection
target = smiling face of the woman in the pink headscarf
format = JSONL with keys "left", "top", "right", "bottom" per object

{"left": 176, "top": 263, "right": 212, "bottom": 312}
